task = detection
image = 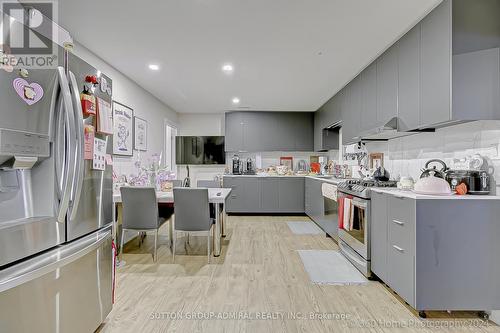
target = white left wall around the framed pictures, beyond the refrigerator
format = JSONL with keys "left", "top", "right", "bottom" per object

{"left": 74, "top": 43, "right": 178, "bottom": 177}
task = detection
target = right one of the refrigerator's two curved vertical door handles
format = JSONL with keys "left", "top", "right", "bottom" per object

{"left": 69, "top": 72, "right": 85, "bottom": 220}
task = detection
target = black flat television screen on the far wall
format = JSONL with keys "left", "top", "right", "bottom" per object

{"left": 175, "top": 136, "right": 226, "bottom": 164}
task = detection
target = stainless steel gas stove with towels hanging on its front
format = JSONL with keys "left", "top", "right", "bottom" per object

{"left": 337, "top": 179, "right": 396, "bottom": 277}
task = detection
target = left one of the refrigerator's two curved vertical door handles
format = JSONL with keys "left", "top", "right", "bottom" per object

{"left": 57, "top": 67, "right": 76, "bottom": 223}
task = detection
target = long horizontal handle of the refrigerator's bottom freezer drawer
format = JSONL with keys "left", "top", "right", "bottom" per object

{"left": 0, "top": 229, "right": 111, "bottom": 293}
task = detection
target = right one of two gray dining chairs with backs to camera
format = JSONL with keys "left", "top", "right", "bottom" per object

{"left": 172, "top": 187, "right": 213, "bottom": 263}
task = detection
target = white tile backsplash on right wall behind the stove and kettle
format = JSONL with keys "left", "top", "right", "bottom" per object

{"left": 366, "top": 120, "right": 500, "bottom": 194}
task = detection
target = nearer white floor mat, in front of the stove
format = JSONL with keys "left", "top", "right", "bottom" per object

{"left": 298, "top": 250, "right": 368, "bottom": 285}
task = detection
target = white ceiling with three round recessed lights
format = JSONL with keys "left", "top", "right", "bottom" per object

{"left": 59, "top": 0, "right": 441, "bottom": 113}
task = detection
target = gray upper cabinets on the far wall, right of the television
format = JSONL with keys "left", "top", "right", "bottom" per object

{"left": 225, "top": 111, "right": 314, "bottom": 152}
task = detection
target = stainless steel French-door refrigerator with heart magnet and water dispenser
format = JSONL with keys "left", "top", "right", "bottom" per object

{"left": 0, "top": 14, "right": 113, "bottom": 333}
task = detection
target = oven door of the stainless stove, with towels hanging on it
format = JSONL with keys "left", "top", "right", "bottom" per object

{"left": 339, "top": 197, "right": 370, "bottom": 260}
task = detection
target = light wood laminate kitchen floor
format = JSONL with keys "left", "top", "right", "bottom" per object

{"left": 98, "top": 216, "right": 500, "bottom": 333}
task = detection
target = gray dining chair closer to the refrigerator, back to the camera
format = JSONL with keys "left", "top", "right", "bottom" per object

{"left": 120, "top": 187, "right": 167, "bottom": 261}
